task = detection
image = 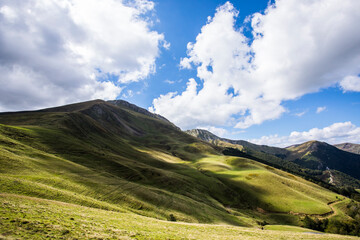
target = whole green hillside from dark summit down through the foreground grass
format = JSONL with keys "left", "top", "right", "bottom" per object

{"left": 0, "top": 100, "right": 358, "bottom": 239}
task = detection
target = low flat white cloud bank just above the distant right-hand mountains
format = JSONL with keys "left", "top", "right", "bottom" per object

{"left": 248, "top": 122, "right": 360, "bottom": 147}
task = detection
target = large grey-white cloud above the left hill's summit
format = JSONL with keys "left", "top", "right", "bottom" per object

{"left": 0, "top": 0, "right": 163, "bottom": 110}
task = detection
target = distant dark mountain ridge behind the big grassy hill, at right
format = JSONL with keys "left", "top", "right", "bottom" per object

{"left": 186, "top": 129, "right": 360, "bottom": 187}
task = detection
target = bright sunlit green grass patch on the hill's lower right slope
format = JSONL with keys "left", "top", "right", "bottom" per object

{"left": 197, "top": 156, "right": 336, "bottom": 214}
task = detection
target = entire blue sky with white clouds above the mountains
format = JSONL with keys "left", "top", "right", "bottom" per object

{"left": 0, "top": 0, "right": 360, "bottom": 147}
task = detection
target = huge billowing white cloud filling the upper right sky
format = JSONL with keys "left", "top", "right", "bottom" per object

{"left": 152, "top": 0, "right": 360, "bottom": 128}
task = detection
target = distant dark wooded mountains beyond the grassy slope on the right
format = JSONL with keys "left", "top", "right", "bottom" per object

{"left": 186, "top": 129, "right": 360, "bottom": 188}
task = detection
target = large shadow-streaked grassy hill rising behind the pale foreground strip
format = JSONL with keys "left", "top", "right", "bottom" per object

{"left": 0, "top": 102, "right": 358, "bottom": 238}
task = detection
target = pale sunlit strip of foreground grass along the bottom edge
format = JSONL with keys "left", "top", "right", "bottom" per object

{"left": 0, "top": 194, "right": 359, "bottom": 240}
